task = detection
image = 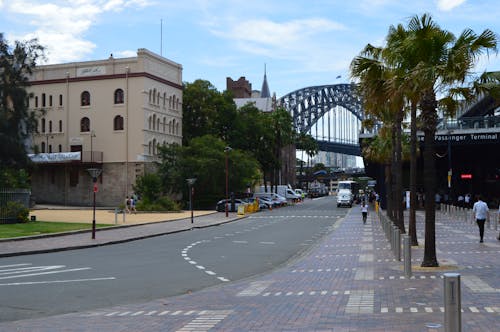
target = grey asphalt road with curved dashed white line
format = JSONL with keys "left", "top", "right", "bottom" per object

{"left": 0, "top": 197, "right": 348, "bottom": 321}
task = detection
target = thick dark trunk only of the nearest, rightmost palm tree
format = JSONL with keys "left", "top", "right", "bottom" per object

{"left": 421, "top": 90, "right": 439, "bottom": 267}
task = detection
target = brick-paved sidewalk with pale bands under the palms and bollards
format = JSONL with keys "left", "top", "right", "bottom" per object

{"left": 0, "top": 204, "right": 500, "bottom": 332}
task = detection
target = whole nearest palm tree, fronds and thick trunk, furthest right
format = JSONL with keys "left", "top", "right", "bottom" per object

{"left": 404, "top": 14, "right": 498, "bottom": 266}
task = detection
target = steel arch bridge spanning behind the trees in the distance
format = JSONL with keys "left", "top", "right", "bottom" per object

{"left": 278, "top": 84, "right": 364, "bottom": 156}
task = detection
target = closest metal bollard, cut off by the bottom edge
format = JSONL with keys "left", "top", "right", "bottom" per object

{"left": 444, "top": 273, "right": 462, "bottom": 332}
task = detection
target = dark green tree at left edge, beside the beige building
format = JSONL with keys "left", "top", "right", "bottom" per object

{"left": 0, "top": 33, "right": 43, "bottom": 183}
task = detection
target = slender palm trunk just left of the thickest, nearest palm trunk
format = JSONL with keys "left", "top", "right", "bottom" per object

{"left": 408, "top": 102, "right": 418, "bottom": 246}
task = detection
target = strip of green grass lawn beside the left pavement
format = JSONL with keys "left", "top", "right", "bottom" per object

{"left": 0, "top": 221, "right": 111, "bottom": 239}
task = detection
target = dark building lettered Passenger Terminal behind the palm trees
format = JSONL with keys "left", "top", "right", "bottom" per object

{"left": 360, "top": 96, "right": 500, "bottom": 209}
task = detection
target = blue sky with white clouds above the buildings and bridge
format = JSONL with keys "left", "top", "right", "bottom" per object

{"left": 0, "top": 0, "right": 500, "bottom": 98}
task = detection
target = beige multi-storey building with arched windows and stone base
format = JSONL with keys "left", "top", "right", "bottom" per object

{"left": 29, "top": 49, "right": 182, "bottom": 206}
